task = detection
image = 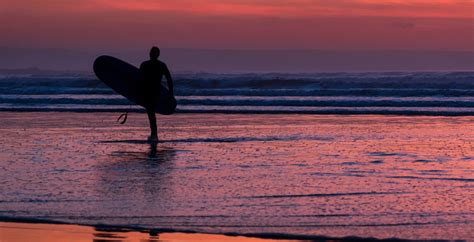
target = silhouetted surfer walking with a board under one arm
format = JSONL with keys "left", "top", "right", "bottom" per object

{"left": 140, "top": 46, "right": 174, "bottom": 142}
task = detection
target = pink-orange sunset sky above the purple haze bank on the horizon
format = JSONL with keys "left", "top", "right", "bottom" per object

{"left": 0, "top": 0, "right": 474, "bottom": 51}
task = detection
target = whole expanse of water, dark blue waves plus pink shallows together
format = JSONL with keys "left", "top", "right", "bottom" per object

{"left": 0, "top": 72, "right": 474, "bottom": 240}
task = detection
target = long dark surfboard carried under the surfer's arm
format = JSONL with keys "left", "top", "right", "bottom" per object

{"left": 93, "top": 55, "right": 177, "bottom": 115}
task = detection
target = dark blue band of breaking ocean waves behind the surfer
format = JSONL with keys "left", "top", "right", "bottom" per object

{"left": 0, "top": 72, "right": 474, "bottom": 115}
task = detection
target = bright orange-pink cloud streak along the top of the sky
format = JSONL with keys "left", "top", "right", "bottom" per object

{"left": 0, "top": 0, "right": 474, "bottom": 18}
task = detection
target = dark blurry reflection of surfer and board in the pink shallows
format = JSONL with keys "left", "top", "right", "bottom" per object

{"left": 97, "top": 143, "right": 176, "bottom": 203}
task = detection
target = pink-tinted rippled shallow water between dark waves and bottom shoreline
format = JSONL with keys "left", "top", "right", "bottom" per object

{"left": 0, "top": 112, "right": 474, "bottom": 239}
